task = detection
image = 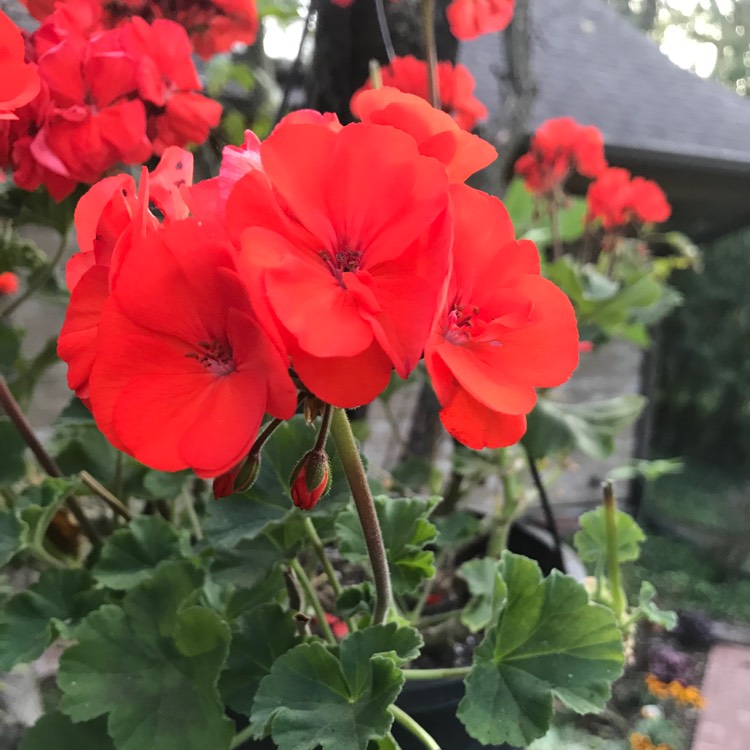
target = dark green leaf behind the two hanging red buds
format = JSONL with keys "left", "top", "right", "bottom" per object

{"left": 203, "top": 415, "right": 350, "bottom": 549}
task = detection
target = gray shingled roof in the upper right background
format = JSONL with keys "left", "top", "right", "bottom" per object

{"left": 460, "top": 0, "right": 750, "bottom": 173}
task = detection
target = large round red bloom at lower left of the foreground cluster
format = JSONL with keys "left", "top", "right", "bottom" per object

{"left": 89, "top": 219, "right": 297, "bottom": 477}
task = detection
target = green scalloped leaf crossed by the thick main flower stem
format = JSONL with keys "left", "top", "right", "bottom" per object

{"left": 336, "top": 496, "right": 439, "bottom": 593}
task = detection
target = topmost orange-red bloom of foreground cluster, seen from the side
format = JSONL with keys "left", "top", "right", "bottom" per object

{"left": 352, "top": 86, "right": 497, "bottom": 182}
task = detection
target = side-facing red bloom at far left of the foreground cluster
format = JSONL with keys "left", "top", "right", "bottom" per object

{"left": 57, "top": 149, "right": 193, "bottom": 403}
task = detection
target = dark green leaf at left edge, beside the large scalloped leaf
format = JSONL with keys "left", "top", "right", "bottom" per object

{"left": 0, "top": 570, "right": 105, "bottom": 671}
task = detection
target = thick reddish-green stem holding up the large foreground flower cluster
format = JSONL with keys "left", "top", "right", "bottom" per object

{"left": 331, "top": 409, "right": 391, "bottom": 625}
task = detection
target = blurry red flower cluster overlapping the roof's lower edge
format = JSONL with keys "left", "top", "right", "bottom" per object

{"left": 516, "top": 117, "right": 607, "bottom": 194}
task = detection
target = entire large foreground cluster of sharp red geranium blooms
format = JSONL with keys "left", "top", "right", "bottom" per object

{"left": 59, "top": 88, "right": 578, "bottom": 484}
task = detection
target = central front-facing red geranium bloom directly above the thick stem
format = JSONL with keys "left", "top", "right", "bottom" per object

{"left": 227, "top": 121, "right": 451, "bottom": 407}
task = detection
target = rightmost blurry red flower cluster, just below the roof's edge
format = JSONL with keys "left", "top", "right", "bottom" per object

{"left": 586, "top": 167, "right": 672, "bottom": 229}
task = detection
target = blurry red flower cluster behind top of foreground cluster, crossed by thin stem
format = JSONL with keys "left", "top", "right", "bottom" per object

{"left": 354, "top": 55, "right": 487, "bottom": 130}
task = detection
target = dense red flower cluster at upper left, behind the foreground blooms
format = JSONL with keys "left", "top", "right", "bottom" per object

{"left": 0, "top": 0, "right": 221, "bottom": 200}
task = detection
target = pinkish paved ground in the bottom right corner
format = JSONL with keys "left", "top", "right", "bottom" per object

{"left": 692, "top": 645, "right": 750, "bottom": 750}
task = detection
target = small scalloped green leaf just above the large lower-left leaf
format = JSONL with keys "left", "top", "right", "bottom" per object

{"left": 92, "top": 516, "right": 183, "bottom": 589}
